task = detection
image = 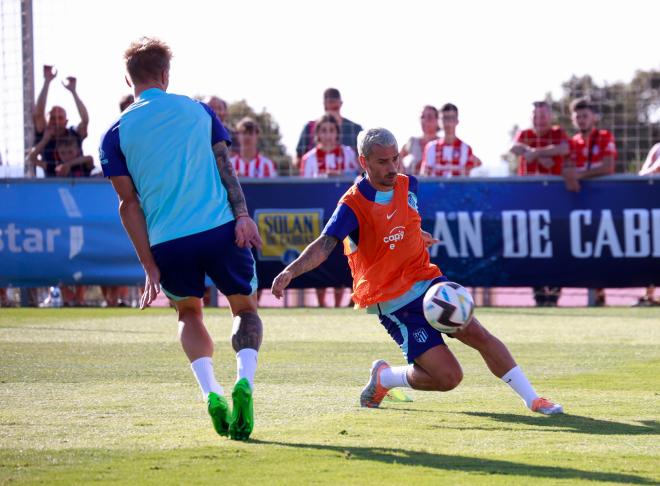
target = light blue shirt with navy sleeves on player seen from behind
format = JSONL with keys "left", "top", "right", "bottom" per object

{"left": 100, "top": 88, "right": 234, "bottom": 246}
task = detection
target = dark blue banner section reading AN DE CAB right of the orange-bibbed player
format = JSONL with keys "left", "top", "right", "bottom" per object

{"left": 418, "top": 176, "right": 660, "bottom": 287}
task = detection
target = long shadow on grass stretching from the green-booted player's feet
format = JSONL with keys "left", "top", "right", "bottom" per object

{"left": 250, "top": 439, "right": 657, "bottom": 484}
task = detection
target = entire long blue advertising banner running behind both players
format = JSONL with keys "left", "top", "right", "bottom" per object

{"left": 0, "top": 176, "right": 660, "bottom": 287}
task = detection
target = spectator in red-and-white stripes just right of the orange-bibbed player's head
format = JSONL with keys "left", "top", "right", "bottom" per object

{"left": 420, "top": 103, "right": 481, "bottom": 177}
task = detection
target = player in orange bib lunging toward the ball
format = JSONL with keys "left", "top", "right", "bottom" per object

{"left": 272, "top": 128, "right": 563, "bottom": 415}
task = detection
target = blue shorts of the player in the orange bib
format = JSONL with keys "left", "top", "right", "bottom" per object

{"left": 378, "top": 276, "right": 447, "bottom": 363}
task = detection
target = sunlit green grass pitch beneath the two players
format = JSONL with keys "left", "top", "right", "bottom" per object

{"left": 0, "top": 308, "right": 660, "bottom": 485}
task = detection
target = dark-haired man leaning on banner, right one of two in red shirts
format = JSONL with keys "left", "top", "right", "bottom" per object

{"left": 563, "top": 98, "right": 617, "bottom": 307}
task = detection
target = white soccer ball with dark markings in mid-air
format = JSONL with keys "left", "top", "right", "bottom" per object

{"left": 424, "top": 282, "right": 474, "bottom": 334}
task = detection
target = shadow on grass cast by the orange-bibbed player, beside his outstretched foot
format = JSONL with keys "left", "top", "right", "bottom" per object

{"left": 462, "top": 412, "right": 660, "bottom": 435}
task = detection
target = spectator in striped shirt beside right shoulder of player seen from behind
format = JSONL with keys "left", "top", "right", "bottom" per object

{"left": 231, "top": 116, "right": 277, "bottom": 179}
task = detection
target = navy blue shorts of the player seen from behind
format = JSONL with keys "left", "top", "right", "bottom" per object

{"left": 151, "top": 221, "right": 257, "bottom": 300}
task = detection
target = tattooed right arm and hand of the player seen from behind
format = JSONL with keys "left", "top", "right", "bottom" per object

{"left": 213, "top": 141, "right": 261, "bottom": 248}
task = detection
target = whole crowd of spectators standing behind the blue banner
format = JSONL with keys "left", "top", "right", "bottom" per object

{"left": 6, "top": 66, "right": 660, "bottom": 306}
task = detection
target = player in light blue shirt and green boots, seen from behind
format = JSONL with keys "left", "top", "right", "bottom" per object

{"left": 100, "top": 37, "right": 263, "bottom": 440}
